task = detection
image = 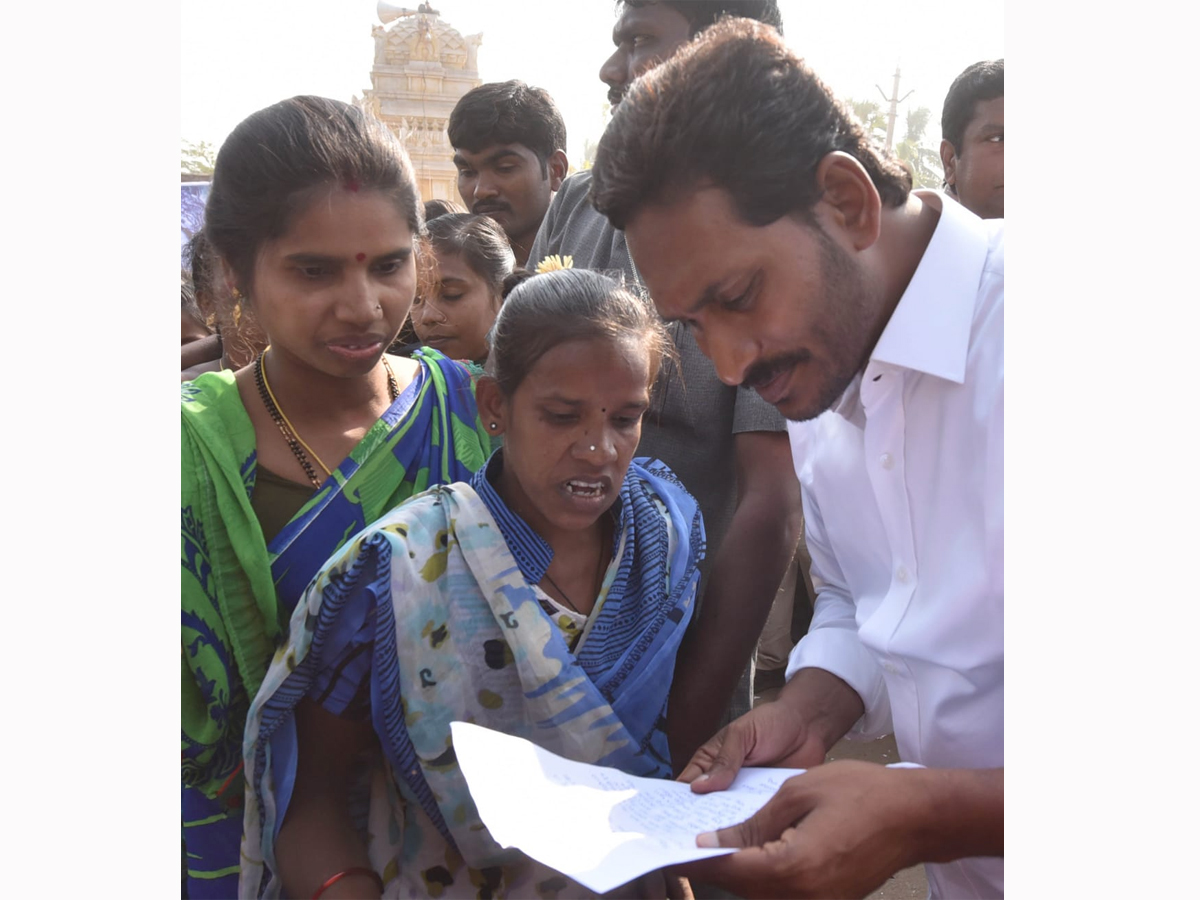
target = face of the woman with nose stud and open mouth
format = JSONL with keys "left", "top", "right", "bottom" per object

{"left": 492, "top": 337, "right": 650, "bottom": 540}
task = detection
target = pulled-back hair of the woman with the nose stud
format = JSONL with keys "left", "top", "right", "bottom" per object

{"left": 486, "top": 269, "right": 674, "bottom": 396}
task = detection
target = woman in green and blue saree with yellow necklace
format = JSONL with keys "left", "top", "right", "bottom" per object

{"left": 180, "top": 97, "right": 490, "bottom": 900}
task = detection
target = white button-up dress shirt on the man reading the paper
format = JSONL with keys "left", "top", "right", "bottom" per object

{"left": 787, "top": 192, "right": 1004, "bottom": 898}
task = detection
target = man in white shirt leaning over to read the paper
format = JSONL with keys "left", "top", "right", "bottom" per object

{"left": 592, "top": 20, "right": 1004, "bottom": 898}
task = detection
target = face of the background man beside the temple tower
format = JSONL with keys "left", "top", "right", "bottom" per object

{"left": 454, "top": 144, "right": 557, "bottom": 248}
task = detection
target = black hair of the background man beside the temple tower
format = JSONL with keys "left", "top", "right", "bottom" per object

{"left": 446, "top": 80, "right": 566, "bottom": 178}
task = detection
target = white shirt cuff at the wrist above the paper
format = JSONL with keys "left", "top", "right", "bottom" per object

{"left": 784, "top": 628, "right": 892, "bottom": 740}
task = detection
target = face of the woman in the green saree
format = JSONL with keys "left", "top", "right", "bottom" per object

{"left": 243, "top": 186, "right": 416, "bottom": 377}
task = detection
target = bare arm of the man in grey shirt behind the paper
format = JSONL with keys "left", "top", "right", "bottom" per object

{"left": 667, "top": 431, "right": 802, "bottom": 772}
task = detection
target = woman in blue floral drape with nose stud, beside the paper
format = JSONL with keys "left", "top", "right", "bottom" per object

{"left": 240, "top": 271, "right": 703, "bottom": 898}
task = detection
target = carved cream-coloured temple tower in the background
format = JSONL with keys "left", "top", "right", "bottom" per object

{"left": 361, "top": 2, "right": 484, "bottom": 202}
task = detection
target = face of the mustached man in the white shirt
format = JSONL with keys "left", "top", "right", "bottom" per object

{"left": 625, "top": 187, "right": 878, "bottom": 421}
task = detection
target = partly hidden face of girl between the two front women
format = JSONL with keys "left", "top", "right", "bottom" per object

{"left": 413, "top": 252, "right": 500, "bottom": 361}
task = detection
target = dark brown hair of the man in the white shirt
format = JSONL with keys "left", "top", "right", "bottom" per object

{"left": 592, "top": 19, "right": 912, "bottom": 228}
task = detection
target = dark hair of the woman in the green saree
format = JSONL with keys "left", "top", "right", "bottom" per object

{"left": 204, "top": 96, "right": 424, "bottom": 293}
